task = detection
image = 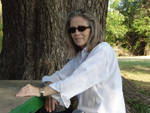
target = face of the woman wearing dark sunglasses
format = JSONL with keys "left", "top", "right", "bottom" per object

{"left": 70, "top": 16, "right": 91, "bottom": 49}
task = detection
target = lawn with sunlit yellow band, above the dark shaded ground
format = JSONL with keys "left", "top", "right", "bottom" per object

{"left": 119, "top": 60, "right": 150, "bottom": 83}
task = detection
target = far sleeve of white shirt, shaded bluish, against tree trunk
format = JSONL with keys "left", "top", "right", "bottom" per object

{"left": 42, "top": 58, "right": 75, "bottom": 82}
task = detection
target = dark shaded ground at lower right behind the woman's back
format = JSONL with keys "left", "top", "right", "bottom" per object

{"left": 123, "top": 78, "right": 150, "bottom": 113}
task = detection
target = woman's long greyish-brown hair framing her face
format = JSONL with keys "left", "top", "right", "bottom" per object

{"left": 65, "top": 9, "right": 105, "bottom": 58}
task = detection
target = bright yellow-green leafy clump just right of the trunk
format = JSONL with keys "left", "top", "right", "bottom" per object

{"left": 106, "top": 10, "right": 128, "bottom": 45}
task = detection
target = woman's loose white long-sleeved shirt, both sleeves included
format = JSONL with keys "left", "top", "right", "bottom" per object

{"left": 42, "top": 42, "right": 125, "bottom": 113}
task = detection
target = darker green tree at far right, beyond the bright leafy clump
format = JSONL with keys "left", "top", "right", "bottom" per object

{"left": 117, "top": 0, "right": 150, "bottom": 55}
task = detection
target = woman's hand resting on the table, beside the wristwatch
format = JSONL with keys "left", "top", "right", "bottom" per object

{"left": 16, "top": 84, "right": 40, "bottom": 97}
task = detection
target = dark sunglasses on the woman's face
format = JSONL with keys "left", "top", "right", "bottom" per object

{"left": 68, "top": 26, "right": 91, "bottom": 33}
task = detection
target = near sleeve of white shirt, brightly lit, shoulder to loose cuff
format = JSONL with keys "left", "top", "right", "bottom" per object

{"left": 49, "top": 45, "right": 111, "bottom": 107}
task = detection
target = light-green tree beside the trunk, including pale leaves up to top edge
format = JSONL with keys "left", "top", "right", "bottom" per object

{"left": 106, "top": 0, "right": 128, "bottom": 46}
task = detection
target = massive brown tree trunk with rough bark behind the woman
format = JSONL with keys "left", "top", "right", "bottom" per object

{"left": 0, "top": 0, "right": 108, "bottom": 79}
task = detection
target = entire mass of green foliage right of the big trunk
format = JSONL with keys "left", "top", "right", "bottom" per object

{"left": 107, "top": 0, "right": 150, "bottom": 55}
